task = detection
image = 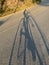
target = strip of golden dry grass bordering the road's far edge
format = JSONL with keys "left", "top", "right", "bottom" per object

{"left": 0, "top": 0, "right": 40, "bottom": 17}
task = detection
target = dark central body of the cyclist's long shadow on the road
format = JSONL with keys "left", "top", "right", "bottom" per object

{"left": 17, "top": 10, "right": 43, "bottom": 65}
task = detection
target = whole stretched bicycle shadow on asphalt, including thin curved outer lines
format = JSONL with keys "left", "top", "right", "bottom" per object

{"left": 8, "top": 10, "right": 48, "bottom": 65}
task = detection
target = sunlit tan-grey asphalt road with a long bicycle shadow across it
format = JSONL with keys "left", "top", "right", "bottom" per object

{"left": 0, "top": 0, "right": 49, "bottom": 65}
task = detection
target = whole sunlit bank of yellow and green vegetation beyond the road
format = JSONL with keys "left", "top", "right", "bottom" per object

{"left": 0, "top": 0, "right": 41, "bottom": 16}
